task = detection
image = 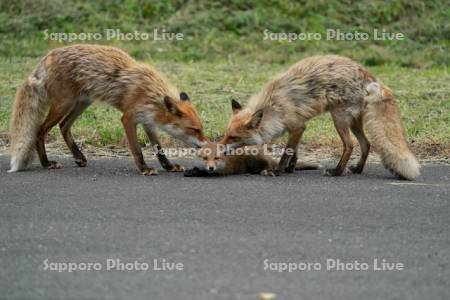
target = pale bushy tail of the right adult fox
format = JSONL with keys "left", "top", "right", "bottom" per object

{"left": 363, "top": 82, "right": 420, "bottom": 180}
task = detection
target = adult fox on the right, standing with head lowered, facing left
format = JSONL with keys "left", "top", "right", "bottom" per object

{"left": 222, "top": 55, "right": 420, "bottom": 180}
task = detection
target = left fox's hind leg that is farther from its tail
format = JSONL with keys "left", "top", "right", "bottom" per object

{"left": 59, "top": 99, "right": 92, "bottom": 167}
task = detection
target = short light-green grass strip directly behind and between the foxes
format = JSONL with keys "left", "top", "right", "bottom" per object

{"left": 0, "top": 59, "right": 450, "bottom": 146}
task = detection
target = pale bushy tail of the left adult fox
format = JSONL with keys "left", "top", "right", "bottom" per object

{"left": 8, "top": 65, "right": 48, "bottom": 172}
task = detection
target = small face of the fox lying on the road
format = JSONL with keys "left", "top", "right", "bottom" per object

{"left": 197, "top": 142, "right": 225, "bottom": 173}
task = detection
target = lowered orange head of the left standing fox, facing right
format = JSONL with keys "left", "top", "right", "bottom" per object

{"left": 159, "top": 92, "right": 207, "bottom": 148}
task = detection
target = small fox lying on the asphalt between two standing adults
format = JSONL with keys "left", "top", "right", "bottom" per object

{"left": 184, "top": 142, "right": 319, "bottom": 177}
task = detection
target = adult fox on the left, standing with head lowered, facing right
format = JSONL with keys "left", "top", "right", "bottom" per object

{"left": 9, "top": 45, "right": 206, "bottom": 175}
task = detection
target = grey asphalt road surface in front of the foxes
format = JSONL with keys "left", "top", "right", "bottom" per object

{"left": 0, "top": 156, "right": 450, "bottom": 300}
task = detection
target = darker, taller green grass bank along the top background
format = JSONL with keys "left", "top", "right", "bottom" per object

{"left": 0, "top": 0, "right": 450, "bottom": 68}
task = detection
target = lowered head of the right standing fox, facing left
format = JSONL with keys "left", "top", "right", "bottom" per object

{"left": 222, "top": 99, "right": 264, "bottom": 148}
